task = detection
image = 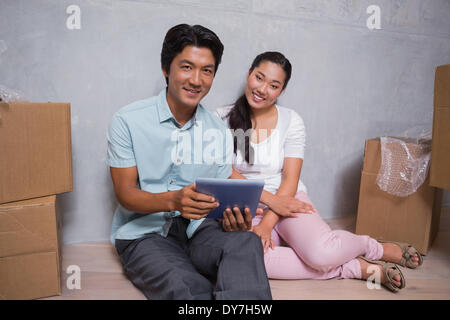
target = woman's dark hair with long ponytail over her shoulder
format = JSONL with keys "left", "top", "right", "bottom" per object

{"left": 227, "top": 51, "right": 292, "bottom": 164}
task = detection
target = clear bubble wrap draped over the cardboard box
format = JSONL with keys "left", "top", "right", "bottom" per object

{"left": 377, "top": 131, "right": 431, "bottom": 197}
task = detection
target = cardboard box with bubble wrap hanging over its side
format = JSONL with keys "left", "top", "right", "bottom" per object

{"left": 356, "top": 139, "right": 442, "bottom": 254}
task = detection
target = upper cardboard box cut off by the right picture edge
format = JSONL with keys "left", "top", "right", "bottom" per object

{"left": 430, "top": 65, "right": 450, "bottom": 190}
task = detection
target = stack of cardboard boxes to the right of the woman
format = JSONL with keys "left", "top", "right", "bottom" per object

{"left": 356, "top": 65, "right": 450, "bottom": 254}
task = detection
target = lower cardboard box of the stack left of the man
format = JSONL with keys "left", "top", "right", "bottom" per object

{"left": 0, "top": 195, "right": 61, "bottom": 299}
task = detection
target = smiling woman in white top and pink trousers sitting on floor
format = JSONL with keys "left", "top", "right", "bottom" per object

{"left": 216, "top": 52, "right": 422, "bottom": 292}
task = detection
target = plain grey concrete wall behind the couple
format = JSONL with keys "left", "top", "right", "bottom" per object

{"left": 0, "top": 0, "right": 450, "bottom": 243}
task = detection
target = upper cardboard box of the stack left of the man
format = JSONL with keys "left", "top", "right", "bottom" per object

{"left": 0, "top": 102, "right": 73, "bottom": 203}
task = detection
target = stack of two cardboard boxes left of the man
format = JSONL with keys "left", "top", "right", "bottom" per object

{"left": 0, "top": 102, "right": 73, "bottom": 299}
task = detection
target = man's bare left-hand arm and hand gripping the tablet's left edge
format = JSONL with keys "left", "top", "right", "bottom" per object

{"left": 110, "top": 166, "right": 219, "bottom": 219}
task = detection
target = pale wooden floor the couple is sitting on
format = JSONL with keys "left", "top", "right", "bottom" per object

{"left": 42, "top": 207, "right": 450, "bottom": 300}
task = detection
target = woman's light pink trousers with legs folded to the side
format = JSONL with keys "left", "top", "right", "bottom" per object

{"left": 252, "top": 191, "right": 383, "bottom": 279}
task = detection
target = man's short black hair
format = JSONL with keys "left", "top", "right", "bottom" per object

{"left": 161, "top": 24, "right": 223, "bottom": 84}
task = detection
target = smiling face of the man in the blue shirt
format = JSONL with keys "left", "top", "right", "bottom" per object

{"left": 163, "top": 46, "right": 215, "bottom": 109}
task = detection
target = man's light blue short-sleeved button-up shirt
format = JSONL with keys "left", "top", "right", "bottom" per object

{"left": 107, "top": 89, "right": 233, "bottom": 244}
